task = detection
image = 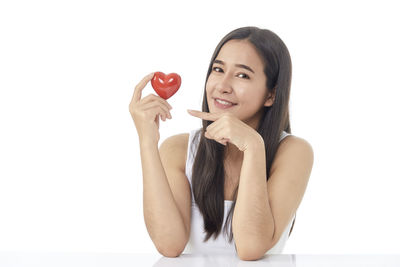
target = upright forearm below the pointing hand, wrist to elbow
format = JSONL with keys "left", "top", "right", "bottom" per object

{"left": 232, "top": 137, "right": 275, "bottom": 255}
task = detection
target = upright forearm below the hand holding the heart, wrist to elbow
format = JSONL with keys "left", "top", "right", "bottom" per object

{"left": 140, "top": 141, "right": 189, "bottom": 257}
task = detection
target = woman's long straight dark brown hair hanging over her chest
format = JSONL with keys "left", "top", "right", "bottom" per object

{"left": 192, "top": 27, "right": 293, "bottom": 245}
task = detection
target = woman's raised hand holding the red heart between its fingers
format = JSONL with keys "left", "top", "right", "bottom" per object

{"left": 129, "top": 72, "right": 172, "bottom": 143}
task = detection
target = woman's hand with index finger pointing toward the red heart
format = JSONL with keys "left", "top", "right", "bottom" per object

{"left": 188, "top": 110, "right": 263, "bottom": 151}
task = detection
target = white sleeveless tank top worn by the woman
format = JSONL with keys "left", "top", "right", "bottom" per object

{"left": 183, "top": 128, "right": 295, "bottom": 254}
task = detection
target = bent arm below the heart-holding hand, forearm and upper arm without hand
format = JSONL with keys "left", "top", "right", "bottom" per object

{"left": 140, "top": 137, "right": 191, "bottom": 257}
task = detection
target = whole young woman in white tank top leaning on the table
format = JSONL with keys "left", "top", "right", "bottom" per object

{"left": 129, "top": 27, "right": 314, "bottom": 260}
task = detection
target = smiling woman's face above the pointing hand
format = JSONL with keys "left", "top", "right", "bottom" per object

{"left": 206, "top": 40, "right": 273, "bottom": 129}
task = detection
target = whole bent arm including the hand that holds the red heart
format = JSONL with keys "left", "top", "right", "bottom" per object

{"left": 129, "top": 73, "right": 191, "bottom": 257}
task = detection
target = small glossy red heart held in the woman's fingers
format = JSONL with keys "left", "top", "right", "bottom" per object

{"left": 151, "top": 71, "right": 181, "bottom": 100}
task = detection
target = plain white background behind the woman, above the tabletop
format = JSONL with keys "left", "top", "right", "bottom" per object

{"left": 0, "top": 0, "right": 400, "bottom": 254}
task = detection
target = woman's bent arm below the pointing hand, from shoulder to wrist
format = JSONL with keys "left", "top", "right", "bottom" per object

{"left": 232, "top": 136, "right": 313, "bottom": 260}
